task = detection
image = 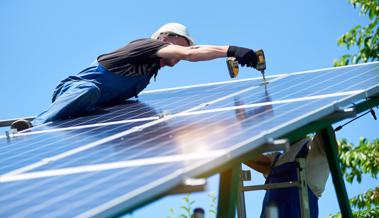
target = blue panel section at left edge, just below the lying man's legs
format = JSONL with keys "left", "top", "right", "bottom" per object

{"left": 0, "top": 118, "right": 151, "bottom": 173}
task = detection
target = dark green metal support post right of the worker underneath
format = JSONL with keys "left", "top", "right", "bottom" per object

{"left": 320, "top": 126, "right": 353, "bottom": 218}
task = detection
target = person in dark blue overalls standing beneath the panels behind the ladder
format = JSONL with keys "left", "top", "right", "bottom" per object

{"left": 246, "top": 134, "right": 329, "bottom": 218}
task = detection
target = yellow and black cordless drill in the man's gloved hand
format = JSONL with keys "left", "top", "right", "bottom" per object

{"left": 226, "top": 49, "right": 267, "bottom": 84}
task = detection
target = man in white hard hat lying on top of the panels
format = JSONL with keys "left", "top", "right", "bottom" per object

{"left": 11, "top": 23, "right": 257, "bottom": 131}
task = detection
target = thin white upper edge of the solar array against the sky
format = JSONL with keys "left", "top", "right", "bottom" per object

{"left": 140, "top": 61, "right": 379, "bottom": 95}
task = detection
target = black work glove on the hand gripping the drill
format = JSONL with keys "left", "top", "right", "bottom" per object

{"left": 226, "top": 45, "right": 257, "bottom": 68}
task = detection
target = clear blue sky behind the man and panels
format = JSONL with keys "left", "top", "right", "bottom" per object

{"left": 0, "top": 0, "right": 379, "bottom": 217}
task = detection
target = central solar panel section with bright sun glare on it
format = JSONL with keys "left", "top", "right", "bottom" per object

{"left": 23, "top": 97, "right": 344, "bottom": 170}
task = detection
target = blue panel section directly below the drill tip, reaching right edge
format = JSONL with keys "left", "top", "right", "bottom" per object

{"left": 207, "top": 65, "right": 379, "bottom": 109}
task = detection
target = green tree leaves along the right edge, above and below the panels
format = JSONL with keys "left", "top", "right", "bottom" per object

{"left": 331, "top": 0, "right": 379, "bottom": 217}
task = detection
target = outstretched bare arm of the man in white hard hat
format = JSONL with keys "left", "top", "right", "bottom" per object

{"left": 157, "top": 44, "right": 229, "bottom": 61}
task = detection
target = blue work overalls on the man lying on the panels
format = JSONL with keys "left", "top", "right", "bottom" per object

{"left": 32, "top": 65, "right": 151, "bottom": 126}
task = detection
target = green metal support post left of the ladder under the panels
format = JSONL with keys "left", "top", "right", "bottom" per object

{"left": 217, "top": 164, "right": 241, "bottom": 218}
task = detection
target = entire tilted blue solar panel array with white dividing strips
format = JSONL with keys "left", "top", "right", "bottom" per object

{"left": 0, "top": 62, "right": 379, "bottom": 217}
